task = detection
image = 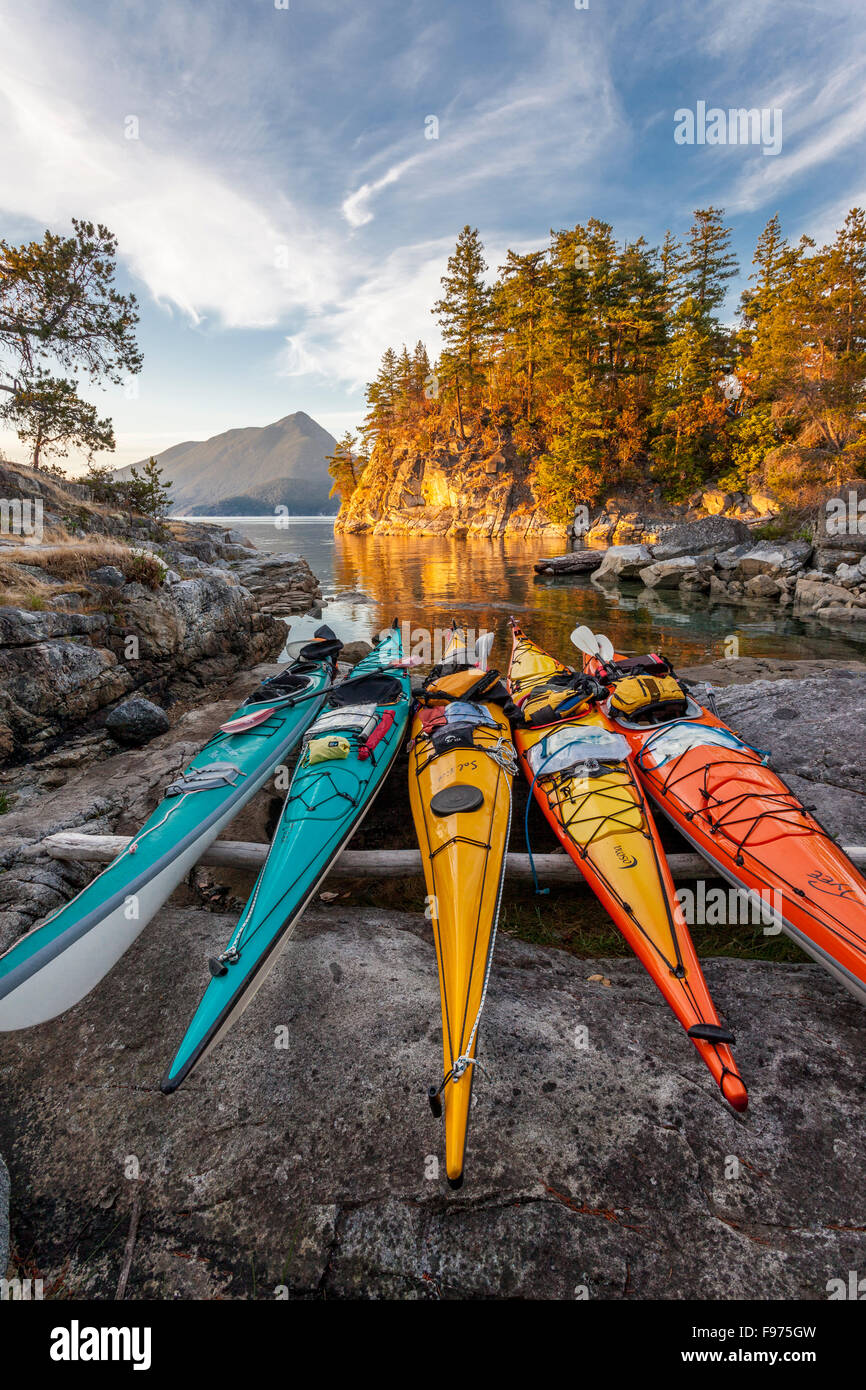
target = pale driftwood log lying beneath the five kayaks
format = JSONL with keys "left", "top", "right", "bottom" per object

{"left": 40, "top": 830, "right": 866, "bottom": 884}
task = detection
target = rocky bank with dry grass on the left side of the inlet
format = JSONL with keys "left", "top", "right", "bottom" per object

{"left": 0, "top": 464, "right": 321, "bottom": 767}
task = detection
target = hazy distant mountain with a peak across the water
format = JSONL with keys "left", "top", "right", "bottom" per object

{"left": 122, "top": 410, "right": 336, "bottom": 516}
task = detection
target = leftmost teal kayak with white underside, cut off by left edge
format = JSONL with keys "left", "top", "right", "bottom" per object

{"left": 0, "top": 627, "right": 342, "bottom": 1033}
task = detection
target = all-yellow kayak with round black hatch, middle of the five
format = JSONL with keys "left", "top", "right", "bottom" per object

{"left": 409, "top": 630, "right": 516, "bottom": 1187}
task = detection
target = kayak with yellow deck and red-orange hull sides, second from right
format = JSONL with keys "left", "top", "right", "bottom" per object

{"left": 507, "top": 621, "right": 748, "bottom": 1111}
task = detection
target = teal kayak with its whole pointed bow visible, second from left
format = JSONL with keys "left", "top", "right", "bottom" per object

{"left": 161, "top": 627, "right": 411, "bottom": 1094}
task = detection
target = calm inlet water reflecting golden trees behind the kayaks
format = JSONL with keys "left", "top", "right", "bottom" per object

{"left": 196, "top": 517, "right": 866, "bottom": 669}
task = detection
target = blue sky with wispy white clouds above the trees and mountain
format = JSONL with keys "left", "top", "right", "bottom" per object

{"left": 0, "top": 0, "right": 866, "bottom": 464}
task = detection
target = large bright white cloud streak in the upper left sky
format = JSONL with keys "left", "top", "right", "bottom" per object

{"left": 0, "top": 21, "right": 343, "bottom": 328}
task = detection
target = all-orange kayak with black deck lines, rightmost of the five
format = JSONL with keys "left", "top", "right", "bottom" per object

{"left": 587, "top": 639, "right": 866, "bottom": 1004}
